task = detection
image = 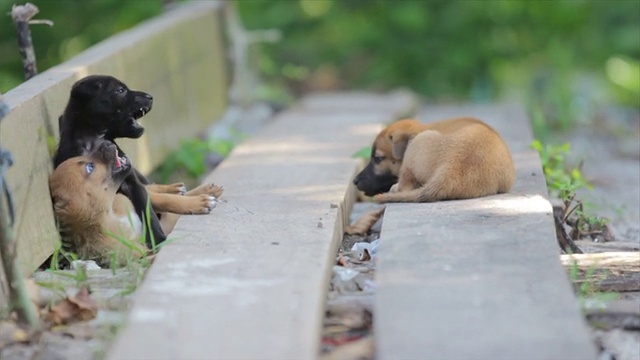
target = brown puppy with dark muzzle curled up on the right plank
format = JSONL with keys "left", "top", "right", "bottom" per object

{"left": 354, "top": 118, "right": 515, "bottom": 202}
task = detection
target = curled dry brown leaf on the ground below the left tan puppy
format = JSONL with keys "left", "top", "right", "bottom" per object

{"left": 47, "top": 285, "right": 98, "bottom": 325}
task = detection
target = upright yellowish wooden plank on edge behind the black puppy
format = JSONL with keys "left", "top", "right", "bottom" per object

{"left": 0, "top": 1, "right": 227, "bottom": 306}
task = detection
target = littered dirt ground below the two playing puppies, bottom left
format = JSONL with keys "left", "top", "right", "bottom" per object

{"left": 0, "top": 265, "right": 144, "bottom": 360}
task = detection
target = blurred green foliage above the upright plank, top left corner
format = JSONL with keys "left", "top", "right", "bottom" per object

{"left": 0, "top": 0, "right": 163, "bottom": 93}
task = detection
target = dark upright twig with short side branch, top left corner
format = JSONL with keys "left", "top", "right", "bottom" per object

{"left": 11, "top": 3, "right": 53, "bottom": 80}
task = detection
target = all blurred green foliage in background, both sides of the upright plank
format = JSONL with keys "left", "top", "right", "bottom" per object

{"left": 0, "top": 0, "right": 640, "bottom": 139}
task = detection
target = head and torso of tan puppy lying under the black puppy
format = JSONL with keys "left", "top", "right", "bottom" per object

{"left": 49, "top": 141, "right": 148, "bottom": 266}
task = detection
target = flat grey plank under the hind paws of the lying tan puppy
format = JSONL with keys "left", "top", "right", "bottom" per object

{"left": 108, "top": 94, "right": 411, "bottom": 359}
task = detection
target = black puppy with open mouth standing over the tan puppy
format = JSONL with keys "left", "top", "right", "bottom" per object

{"left": 53, "top": 75, "right": 166, "bottom": 247}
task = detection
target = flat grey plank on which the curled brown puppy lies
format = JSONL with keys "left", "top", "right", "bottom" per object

{"left": 374, "top": 105, "right": 595, "bottom": 359}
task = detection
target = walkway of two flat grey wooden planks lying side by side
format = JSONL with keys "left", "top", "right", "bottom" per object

{"left": 108, "top": 94, "right": 595, "bottom": 360}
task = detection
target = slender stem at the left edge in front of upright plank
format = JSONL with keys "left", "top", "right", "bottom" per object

{"left": 0, "top": 149, "right": 40, "bottom": 329}
